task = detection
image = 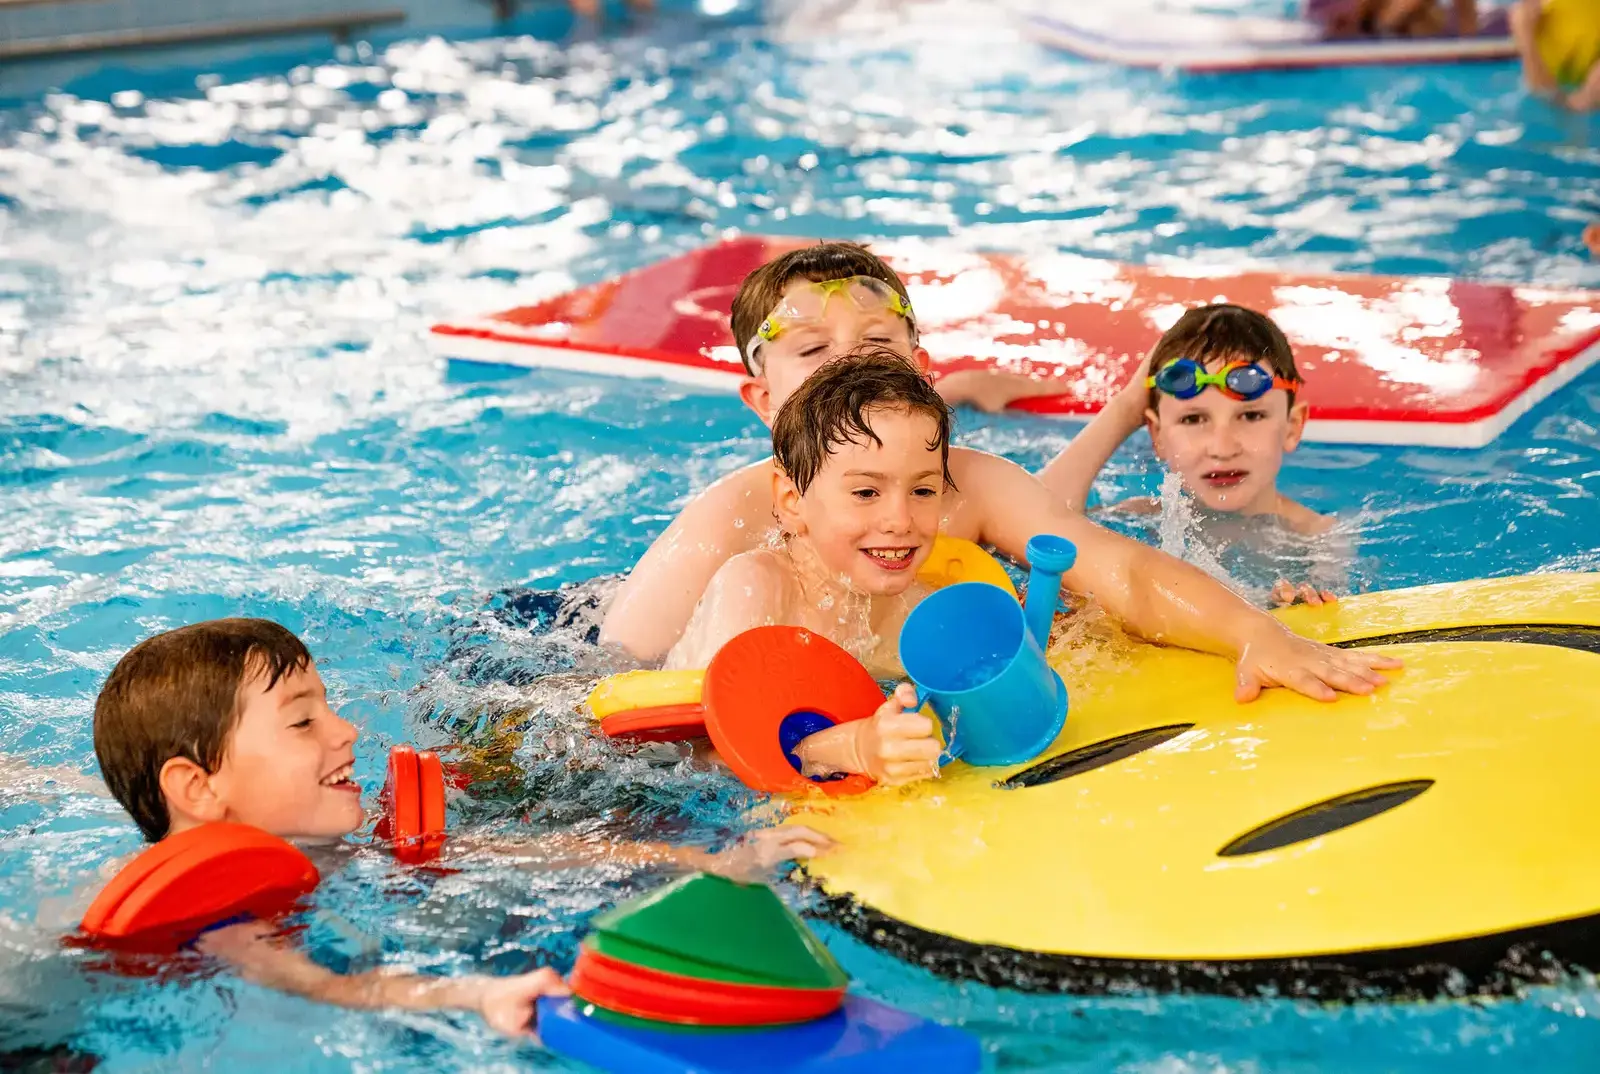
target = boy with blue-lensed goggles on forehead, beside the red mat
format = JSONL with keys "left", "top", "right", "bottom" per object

{"left": 1040, "top": 304, "right": 1333, "bottom": 603}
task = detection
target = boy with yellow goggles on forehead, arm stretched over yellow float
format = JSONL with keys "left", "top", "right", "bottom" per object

{"left": 600, "top": 243, "right": 1398, "bottom": 701}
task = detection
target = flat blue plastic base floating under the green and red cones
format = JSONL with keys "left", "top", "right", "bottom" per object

{"left": 538, "top": 996, "right": 982, "bottom": 1074}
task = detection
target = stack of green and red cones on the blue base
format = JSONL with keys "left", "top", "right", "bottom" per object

{"left": 571, "top": 874, "right": 850, "bottom": 1028}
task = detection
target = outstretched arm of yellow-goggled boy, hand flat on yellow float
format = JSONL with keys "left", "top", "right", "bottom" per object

{"left": 957, "top": 453, "right": 1400, "bottom": 701}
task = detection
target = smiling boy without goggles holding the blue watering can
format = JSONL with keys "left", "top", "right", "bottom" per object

{"left": 667, "top": 347, "right": 954, "bottom": 783}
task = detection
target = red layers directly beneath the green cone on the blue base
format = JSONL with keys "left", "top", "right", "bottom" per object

{"left": 571, "top": 948, "right": 845, "bottom": 1026}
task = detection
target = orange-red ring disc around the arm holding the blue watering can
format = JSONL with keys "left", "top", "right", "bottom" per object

{"left": 704, "top": 626, "right": 883, "bottom": 795}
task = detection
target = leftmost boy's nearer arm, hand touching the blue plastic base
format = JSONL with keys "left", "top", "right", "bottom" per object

{"left": 197, "top": 922, "right": 568, "bottom": 1036}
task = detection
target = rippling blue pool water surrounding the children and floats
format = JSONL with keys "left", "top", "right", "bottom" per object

{"left": 0, "top": 0, "right": 1600, "bottom": 1074}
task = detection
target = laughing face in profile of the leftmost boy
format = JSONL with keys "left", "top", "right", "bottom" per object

{"left": 206, "top": 667, "right": 363, "bottom": 839}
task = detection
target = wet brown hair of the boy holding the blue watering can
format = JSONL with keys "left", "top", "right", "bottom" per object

{"left": 773, "top": 347, "right": 955, "bottom": 496}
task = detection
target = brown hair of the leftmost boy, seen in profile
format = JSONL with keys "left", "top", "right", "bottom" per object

{"left": 94, "top": 619, "right": 312, "bottom": 842}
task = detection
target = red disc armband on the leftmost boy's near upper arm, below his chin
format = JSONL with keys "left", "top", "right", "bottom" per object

{"left": 80, "top": 823, "right": 322, "bottom": 951}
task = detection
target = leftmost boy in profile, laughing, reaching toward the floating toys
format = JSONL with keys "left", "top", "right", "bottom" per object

{"left": 94, "top": 619, "right": 827, "bottom": 1034}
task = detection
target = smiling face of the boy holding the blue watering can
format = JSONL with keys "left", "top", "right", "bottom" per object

{"left": 774, "top": 408, "right": 944, "bottom": 595}
